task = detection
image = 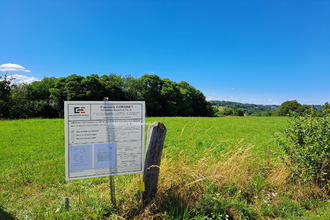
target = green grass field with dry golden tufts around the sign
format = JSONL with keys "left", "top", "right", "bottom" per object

{"left": 0, "top": 117, "right": 330, "bottom": 219}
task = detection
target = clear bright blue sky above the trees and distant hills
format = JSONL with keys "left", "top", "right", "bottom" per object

{"left": 0, "top": 0, "right": 330, "bottom": 104}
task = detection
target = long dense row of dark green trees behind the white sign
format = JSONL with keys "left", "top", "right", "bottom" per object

{"left": 0, "top": 74, "right": 214, "bottom": 119}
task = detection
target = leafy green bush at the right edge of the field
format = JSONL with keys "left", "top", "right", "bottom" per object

{"left": 278, "top": 109, "right": 330, "bottom": 188}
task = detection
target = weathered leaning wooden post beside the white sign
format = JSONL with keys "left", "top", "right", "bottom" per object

{"left": 143, "top": 122, "right": 166, "bottom": 207}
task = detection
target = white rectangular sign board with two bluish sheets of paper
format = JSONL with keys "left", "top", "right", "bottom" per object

{"left": 64, "top": 101, "right": 145, "bottom": 180}
